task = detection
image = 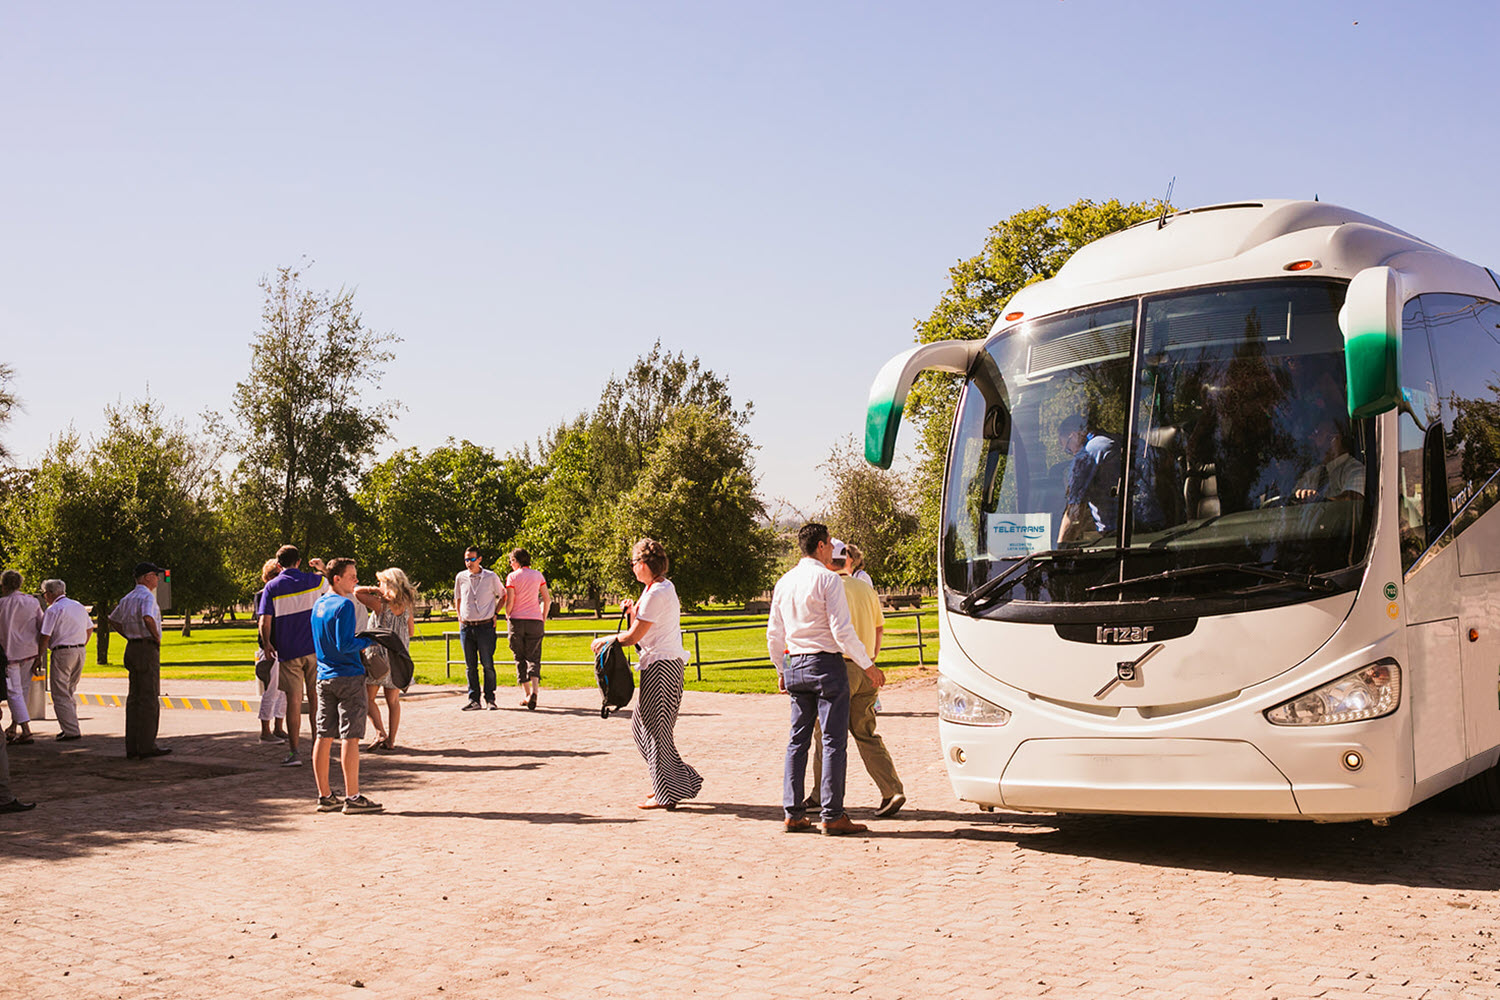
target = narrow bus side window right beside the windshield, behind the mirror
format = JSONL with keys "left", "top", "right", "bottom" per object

{"left": 1397, "top": 298, "right": 1448, "bottom": 570}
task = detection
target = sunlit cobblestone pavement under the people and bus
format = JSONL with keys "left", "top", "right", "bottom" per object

{"left": 0, "top": 671, "right": 1500, "bottom": 1000}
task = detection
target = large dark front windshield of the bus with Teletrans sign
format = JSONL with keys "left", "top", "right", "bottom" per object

{"left": 942, "top": 280, "right": 1377, "bottom": 619}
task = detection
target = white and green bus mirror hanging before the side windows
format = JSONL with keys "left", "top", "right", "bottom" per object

{"left": 1338, "top": 267, "right": 1401, "bottom": 418}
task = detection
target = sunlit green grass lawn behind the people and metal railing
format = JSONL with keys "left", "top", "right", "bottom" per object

{"left": 84, "top": 609, "right": 938, "bottom": 691}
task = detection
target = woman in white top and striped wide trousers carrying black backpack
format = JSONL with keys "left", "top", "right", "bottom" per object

{"left": 593, "top": 538, "right": 704, "bottom": 810}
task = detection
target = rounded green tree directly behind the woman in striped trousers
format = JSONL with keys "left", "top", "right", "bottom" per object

{"left": 611, "top": 405, "right": 776, "bottom": 606}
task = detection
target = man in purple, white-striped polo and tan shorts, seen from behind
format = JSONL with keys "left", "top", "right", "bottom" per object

{"left": 255, "top": 546, "right": 324, "bottom": 768}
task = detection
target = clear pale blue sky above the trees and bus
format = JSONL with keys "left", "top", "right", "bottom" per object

{"left": 0, "top": 0, "right": 1500, "bottom": 510}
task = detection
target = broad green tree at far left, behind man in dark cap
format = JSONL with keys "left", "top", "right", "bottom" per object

{"left": 9, "top": 399, "right": 236, "bottom": 656}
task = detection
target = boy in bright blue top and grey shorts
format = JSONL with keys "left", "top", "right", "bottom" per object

{"left": 312, "top": 559, "right": 381, "bottom": 813}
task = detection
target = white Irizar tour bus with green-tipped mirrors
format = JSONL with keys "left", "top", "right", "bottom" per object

{"left": 866, "top": 201, "right": 1500, "bottom": 822}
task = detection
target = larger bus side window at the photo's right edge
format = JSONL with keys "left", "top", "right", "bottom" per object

{"left": 1422, "top": 295, "right": 1500, "bottom": 519}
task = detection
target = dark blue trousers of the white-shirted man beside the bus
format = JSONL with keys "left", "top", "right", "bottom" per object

{"left": 782, "top": 652, "right": 849, "bottom": 823}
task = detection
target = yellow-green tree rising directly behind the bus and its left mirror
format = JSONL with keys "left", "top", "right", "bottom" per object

{"left": 906, "top": 198, "right": 1170, "bottom": 554}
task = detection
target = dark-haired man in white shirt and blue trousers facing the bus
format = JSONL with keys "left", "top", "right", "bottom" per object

{"left": 765, "top": 522, "right": 885, "bottom": 837}
